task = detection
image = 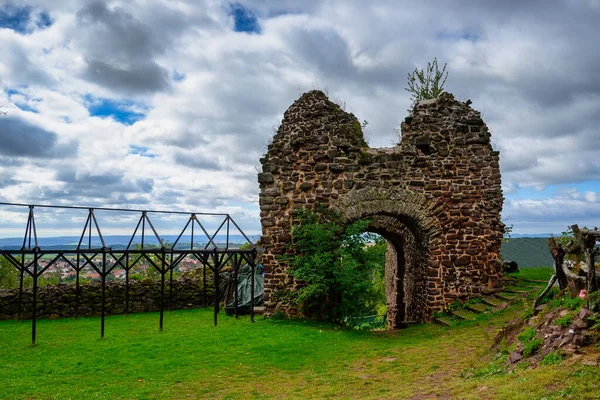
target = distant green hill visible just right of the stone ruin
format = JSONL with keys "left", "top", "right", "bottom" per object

{"left": 500, "top": 236, "right": 554, "bottom": 268}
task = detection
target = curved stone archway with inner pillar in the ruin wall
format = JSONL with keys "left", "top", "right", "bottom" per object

{"left": 331, "top": 188, "right": 441, "bottom": 329}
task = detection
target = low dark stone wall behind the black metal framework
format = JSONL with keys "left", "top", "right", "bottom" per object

{"left": 0, "top": 278, "right": 214, "bottom": 320}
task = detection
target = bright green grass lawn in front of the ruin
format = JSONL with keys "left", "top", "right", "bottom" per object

{"left": 0, "top": 269, "right": 600, "bottom": 399}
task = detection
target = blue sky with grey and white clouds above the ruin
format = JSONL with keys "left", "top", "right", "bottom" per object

{"left": 0, "top": 0, "right": 600, "bottom": 236}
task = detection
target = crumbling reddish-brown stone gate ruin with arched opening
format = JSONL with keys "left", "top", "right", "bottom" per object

{"left": 258, "top": 90, "right": 504, "bottom": 329}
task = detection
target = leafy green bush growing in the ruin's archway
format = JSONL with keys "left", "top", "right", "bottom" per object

{"left": 282, "top": 206, "right": 385, "bottom": 322}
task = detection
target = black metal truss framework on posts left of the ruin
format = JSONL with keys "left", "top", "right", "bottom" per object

{"left": 0, "top": 203, "right": 257, "bottom": 344}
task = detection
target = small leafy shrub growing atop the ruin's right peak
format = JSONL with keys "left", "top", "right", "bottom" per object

{"left": 406, "top": 58, "right": 448, "bottom": 112}
